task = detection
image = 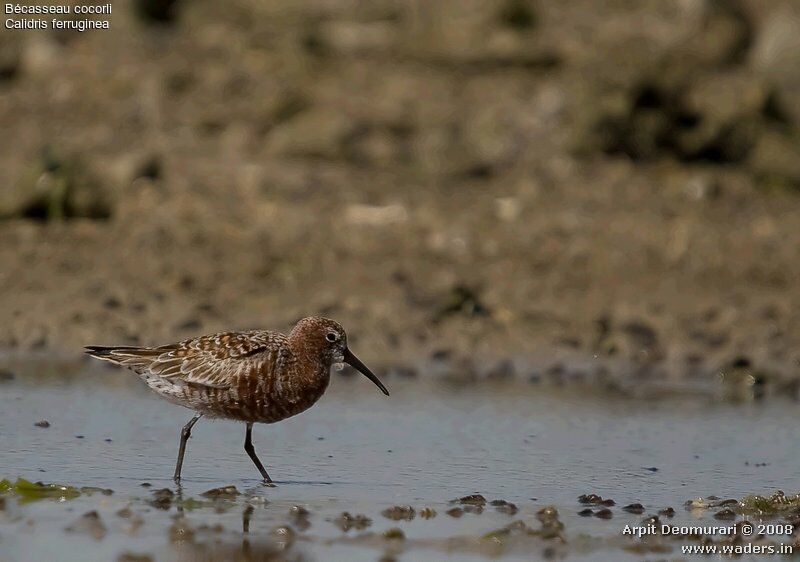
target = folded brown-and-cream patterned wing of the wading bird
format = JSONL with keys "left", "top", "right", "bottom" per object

{"left": 89, "top": 331, "right": 288, "bottom": 388}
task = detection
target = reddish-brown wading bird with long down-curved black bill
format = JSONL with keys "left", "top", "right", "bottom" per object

{"left": 86, "top": 316, "right": 389, "bottom": 482}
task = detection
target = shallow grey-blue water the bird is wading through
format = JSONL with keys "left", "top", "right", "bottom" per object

{"left": 0, "top": 369, "right": 800, "bottom": 562}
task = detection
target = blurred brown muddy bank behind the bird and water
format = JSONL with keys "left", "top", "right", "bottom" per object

{"left": 0, "top": 0, "right": 800, "bottom": 392}
